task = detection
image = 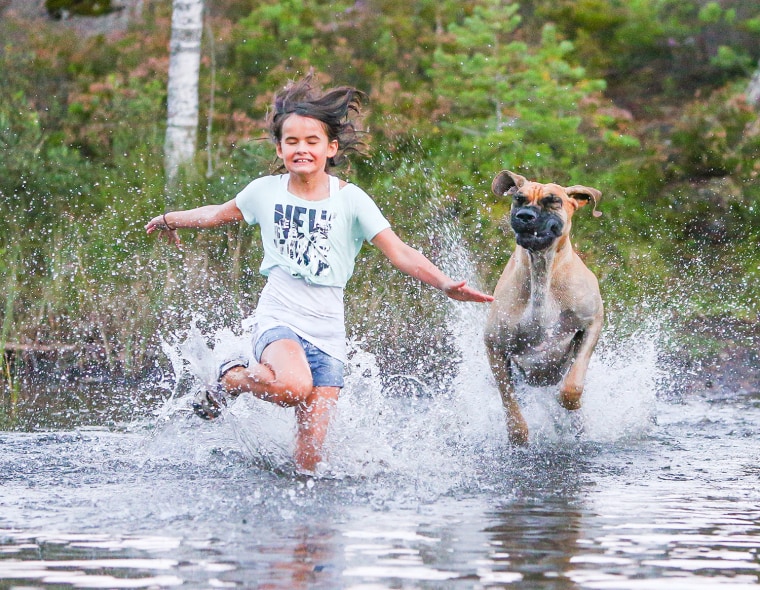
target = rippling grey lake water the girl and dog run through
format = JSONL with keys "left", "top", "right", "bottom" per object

{"left": 0, "top": 304, "right": 760, "bottom": 590}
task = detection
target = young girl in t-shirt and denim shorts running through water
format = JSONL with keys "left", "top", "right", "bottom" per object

{"left": 145, "top": 76, "right": 493, "bottom": 472}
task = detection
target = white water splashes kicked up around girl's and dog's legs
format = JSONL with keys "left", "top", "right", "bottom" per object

{"left": 151, "top": 222, "right": 662, "bottom": 496}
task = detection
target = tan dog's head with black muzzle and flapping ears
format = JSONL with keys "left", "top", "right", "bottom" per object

{"left": 491, "top": 170, "right": 602, "bottom": 251}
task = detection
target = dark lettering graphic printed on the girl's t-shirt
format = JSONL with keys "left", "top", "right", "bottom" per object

{"left": 274, "top": 203, "right": 334, "bottom": 277}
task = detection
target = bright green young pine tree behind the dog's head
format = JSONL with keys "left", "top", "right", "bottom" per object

{"left": 430, "top": 0, "right": 604, "bottom": 180}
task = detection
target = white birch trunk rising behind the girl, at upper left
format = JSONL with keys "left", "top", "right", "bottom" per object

{"left": 164, "top": 0, "right": 203, "bottom": 185}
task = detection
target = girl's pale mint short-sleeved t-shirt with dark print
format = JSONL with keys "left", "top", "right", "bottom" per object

{"left": 235, "top": 174, "right": 390, "bottom": 288}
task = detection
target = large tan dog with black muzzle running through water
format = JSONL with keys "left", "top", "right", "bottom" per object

{"left": 485, "top": 170, "right": 604, "bottom": 444}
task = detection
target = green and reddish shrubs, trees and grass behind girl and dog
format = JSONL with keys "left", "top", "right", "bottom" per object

{"left": 0, "top": 0, "right": 760, "bottom": 412}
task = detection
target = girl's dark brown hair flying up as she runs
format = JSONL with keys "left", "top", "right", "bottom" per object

{"left": 268, "top": 73, "right": 367, "bottom": 168}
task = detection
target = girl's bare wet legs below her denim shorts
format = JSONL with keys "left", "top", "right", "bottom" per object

{"left": 221, "top": 339, "right": 340, "bottom": 471}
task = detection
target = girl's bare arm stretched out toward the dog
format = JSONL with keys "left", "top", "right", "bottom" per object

{"left": 372, "top": 228, "right": 493, "bottom": 303}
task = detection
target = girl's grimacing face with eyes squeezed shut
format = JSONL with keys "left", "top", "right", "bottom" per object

{"left": 277, "top": 113, "right": 338, "bottom": 176}
